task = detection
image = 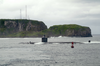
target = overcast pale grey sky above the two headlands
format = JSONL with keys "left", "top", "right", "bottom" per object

{"left": 0, "top": 0, "right": 100, "bottom": 34}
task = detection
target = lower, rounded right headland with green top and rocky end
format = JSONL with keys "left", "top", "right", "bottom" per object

{"left": 49, "top": 24, "right": 92, "bottom": 37}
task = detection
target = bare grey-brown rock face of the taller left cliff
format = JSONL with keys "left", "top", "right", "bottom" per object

{"left": 4, "top": 20, "right": 47, "bottom": 31}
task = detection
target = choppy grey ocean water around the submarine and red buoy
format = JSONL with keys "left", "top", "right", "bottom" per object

{"left": 0, "top": 35, "right": 100, "bottom": 66}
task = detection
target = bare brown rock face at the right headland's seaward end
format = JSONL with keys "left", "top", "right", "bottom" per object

{"left": 65, "top": 27, "right": 92, "bottom": 37}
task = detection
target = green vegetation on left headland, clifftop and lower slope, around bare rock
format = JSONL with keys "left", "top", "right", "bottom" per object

{"left": 0, "top": 19, "right": 45, "bottom": 37}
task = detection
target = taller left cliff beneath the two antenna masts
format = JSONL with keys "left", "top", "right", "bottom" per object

{"left": 0, "top": 19, "right": 47, "bottom": 37}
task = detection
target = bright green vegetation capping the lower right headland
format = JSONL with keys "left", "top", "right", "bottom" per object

{"left": 49, "top": 24, "right": 87, "bottom": 35}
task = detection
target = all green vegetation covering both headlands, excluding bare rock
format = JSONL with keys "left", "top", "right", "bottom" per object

{"left": 0, "top": 19, "right": 91, "bottom": 37}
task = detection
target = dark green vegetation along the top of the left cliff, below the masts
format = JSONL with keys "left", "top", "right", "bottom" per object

{"left": 0, "top": 19, "right": 40, "bottom": 32}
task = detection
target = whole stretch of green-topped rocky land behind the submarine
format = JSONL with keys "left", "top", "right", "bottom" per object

{"left": 0, "top": 19, "right": 92, "bottom": 38}
